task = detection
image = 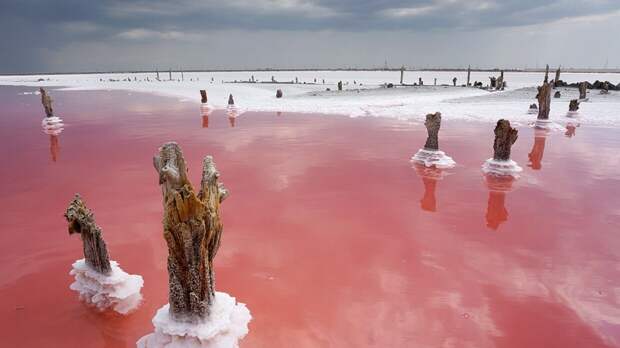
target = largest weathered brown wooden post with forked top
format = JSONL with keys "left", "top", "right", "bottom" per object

{"left": 153, "top": 142, "right": 228, "bottom": 322}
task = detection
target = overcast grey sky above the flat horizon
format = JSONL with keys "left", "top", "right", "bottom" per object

{"left": 0, "top": 0, "right": 620, "bottom": 73}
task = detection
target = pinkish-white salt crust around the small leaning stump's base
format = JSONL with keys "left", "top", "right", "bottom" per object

{"left": 69, "top": 259, "right": 144, "bottom": 314}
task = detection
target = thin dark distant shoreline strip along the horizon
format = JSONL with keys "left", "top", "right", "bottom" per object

{"left": 0, "top": 67, "right": 620, "bottom": 76}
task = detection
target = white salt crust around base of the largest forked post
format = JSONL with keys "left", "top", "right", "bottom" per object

{"left": 136, "top": 292, "right": 252, "bottom": 348}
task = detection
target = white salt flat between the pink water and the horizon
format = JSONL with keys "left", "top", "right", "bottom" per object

{"left": 0, "top": 71, "right": 620, "bottom": 127}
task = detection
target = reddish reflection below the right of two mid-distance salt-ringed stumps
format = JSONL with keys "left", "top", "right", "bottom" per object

{"left": 484, "top": 174, "right": 515, "bottom": 230}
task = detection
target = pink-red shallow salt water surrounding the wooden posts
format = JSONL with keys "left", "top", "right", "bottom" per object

{"left": 0, "top": 87, "right": 620, "bottom": 348}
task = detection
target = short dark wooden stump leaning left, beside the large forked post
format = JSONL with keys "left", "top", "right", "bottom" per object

{"left": 65, "top": 194, "right": 112, "bottom": 274}
